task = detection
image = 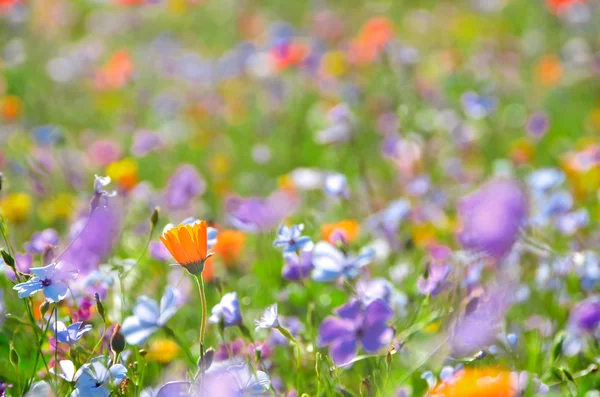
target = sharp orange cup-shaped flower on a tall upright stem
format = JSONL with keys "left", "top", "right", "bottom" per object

{"left": 160, "top": 221, "right": 213, "bottom": 274}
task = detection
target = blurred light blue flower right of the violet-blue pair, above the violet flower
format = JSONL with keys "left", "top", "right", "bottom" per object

{"left": 311, "top": 241, "right": 375, "bottom": 283}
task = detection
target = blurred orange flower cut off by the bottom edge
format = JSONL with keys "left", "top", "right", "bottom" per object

{"left": 428, "top": 368, "right": 517, "bottom": 397}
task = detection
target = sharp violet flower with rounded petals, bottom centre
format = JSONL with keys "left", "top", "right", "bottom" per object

{"left": 318, "top": 299, "right": 394, "bottom": 366}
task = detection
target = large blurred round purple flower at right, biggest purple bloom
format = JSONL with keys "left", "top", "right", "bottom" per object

{"left": 458, "top": 179, "right": 527, "bottom": 259}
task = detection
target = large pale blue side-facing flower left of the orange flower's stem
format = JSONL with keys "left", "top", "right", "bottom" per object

{"left": 121, "top": 287, "right": 179, "bottom": 345}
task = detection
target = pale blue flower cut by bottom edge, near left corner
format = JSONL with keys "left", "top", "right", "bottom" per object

{"left": 71, "top": 357, "right": 127, "bottom": 397}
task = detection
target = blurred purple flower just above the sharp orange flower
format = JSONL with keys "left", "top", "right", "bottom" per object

{"left": 165, "top": 164, "right": 206, "bottom": 211}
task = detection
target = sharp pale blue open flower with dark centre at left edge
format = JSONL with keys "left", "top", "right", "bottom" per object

{"left": 13, "top": 262, "right": 77, "bottom": 302}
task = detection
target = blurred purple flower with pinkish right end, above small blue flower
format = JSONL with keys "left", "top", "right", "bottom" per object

{"left": 225, "top": 190, "right": 299, "bottom": 233}
